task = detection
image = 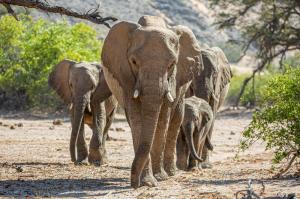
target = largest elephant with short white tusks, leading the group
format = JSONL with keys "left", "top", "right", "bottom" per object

{"left": 102, "top": 16, "right": 201, "bottom": 188}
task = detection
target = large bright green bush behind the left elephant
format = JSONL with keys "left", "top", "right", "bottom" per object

{"left": 0, "top": 16, "right": 101, "bottom": 108}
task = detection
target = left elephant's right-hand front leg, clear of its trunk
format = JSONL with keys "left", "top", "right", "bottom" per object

{"left": 88, "top": 102, "right": 106, "bottom": 166}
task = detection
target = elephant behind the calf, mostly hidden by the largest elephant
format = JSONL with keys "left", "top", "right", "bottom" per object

{"left": 186, "top": 47, "right": 232, "bottom": 168}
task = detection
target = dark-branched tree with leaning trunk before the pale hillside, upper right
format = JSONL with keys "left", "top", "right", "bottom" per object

{"left": 210, "top": 0, "right": 300, "bottom": 106}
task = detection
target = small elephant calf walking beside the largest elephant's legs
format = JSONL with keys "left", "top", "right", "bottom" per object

{"left": 177, "top": 96, "right": 214, "bottom": 170}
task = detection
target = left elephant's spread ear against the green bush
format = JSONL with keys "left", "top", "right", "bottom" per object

{"left": 48, "top": 59, "right": 76, "bottom": 104}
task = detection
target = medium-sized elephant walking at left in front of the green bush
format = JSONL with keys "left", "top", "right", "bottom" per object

{"left": 49, "top": 60, "right": 117, "bottom": 165}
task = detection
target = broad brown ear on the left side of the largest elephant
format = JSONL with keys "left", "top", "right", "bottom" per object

{"left": 101, "top": 21, "right": 140, "bottom": 105}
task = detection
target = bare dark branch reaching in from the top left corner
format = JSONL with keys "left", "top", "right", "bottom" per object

{"left": 0, "top": 0, "right": 117, "bottom": 28}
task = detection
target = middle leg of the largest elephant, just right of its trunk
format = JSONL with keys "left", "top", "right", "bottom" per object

{"left": 151, "top": 104, "right": 171, "bottom": 181}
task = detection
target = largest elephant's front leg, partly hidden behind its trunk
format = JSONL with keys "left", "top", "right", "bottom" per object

{"left": 125, "top": 100, "right": 157, "bottom": 187}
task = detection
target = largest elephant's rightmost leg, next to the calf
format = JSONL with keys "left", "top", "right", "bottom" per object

{"left": 164, "top": 99, "right": 184, "bottom": 176}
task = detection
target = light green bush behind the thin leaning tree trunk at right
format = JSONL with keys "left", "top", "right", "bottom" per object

{"left": 226, "top": 72, "right": 272, "bottom": 106}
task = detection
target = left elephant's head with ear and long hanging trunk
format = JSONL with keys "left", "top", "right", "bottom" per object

{"left": 49, "top": 60, "right": 100, "bottom": 162}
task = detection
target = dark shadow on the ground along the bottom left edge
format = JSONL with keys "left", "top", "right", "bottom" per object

{"left": 0, "top": 178, "right": 130, "bottom": 198}
